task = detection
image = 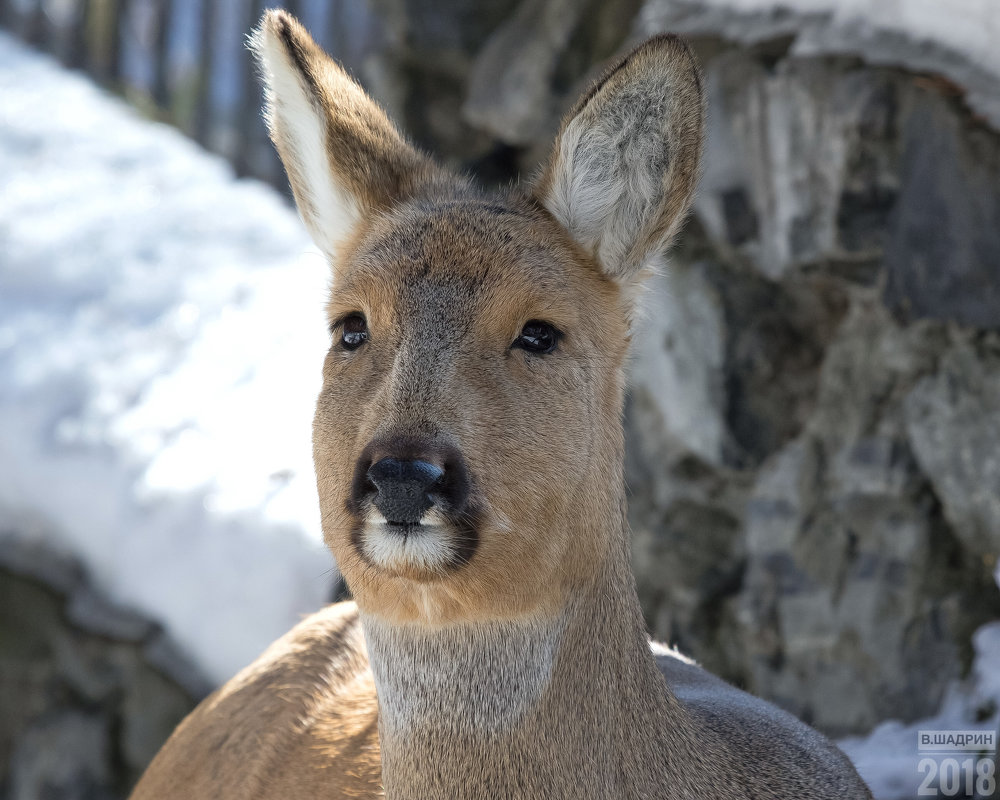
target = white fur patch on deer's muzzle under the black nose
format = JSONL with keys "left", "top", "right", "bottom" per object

{"left": 361, "top": 513, "right": 455, "bottom": 572}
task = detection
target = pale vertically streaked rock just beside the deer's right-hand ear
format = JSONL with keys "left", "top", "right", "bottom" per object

{"left": 697, "top": 52, "right": 855, "bottom": 279}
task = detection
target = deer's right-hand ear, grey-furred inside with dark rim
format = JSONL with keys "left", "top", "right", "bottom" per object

{"left": 534, "top": 36, "right": 705, "bottom": 282}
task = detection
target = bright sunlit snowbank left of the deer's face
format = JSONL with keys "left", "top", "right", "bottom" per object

{"left": 0, "top": 35, "right": 334, "bottom": 682}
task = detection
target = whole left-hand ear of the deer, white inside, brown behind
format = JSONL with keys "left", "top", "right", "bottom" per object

{"left": 250, "top": 10, "right": 435, "bottom": 263}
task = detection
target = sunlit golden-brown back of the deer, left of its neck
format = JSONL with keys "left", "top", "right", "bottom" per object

{"left": 132, "top": 603, "right": 381, "bottom": 800}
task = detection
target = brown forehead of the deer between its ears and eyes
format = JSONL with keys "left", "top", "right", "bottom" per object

{"left": 328, "top": 201, "right": 619, "bottom": 339}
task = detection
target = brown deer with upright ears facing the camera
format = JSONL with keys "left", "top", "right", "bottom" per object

{"left": 132, "top": 10, "right": 871, "bottom": 800}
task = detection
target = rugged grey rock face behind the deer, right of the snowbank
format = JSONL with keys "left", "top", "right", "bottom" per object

{"left": 364, "top": 0, "right": 1000, "bottom": 734}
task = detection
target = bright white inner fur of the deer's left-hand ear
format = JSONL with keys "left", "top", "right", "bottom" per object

{"left": 251, "top": 26, "right": 361, "bottom": 259}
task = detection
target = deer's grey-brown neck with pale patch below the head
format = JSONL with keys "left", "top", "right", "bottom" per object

{"left": 362, "top": 538, "right": 694, "bottom": 800}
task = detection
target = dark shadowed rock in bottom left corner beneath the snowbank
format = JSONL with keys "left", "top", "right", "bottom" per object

{"left": 0, "top": 533, "right": 209, "bottom": 800}
